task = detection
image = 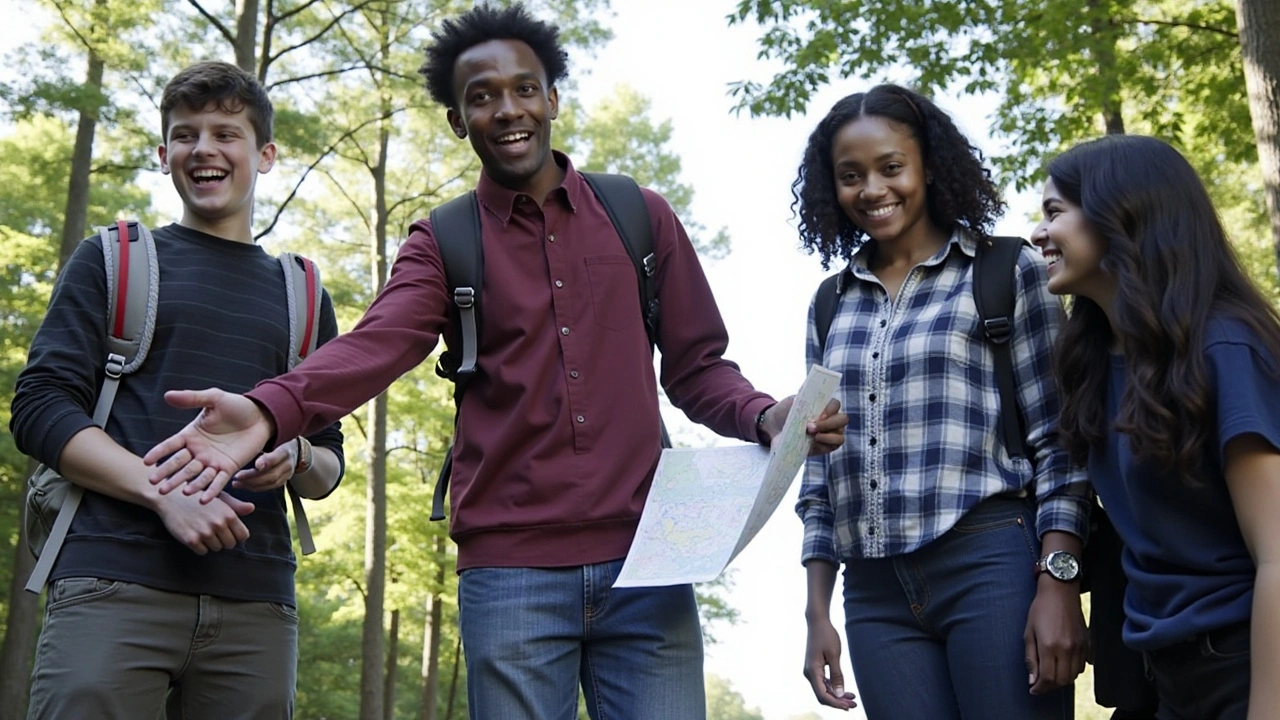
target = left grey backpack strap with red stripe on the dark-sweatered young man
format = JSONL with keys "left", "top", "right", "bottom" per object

{"left": 26, "top": 220, "right": 160, "bottom": 594}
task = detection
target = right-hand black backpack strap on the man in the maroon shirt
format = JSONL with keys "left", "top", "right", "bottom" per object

{"left": 581, "top": 173, "right": 669, "bottom": 348}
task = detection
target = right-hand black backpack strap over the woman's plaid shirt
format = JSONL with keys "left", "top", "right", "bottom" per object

{"left": 973, "top": 237, "right": 1030, "bottom": 459}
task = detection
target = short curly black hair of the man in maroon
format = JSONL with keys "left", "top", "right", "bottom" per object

{"left": 417, "top": 3, "right": 568, "bottom": 110}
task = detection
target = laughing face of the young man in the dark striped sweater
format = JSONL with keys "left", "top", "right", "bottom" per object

{"left": 159, "top": 102, "right": 275, "bottom": 242}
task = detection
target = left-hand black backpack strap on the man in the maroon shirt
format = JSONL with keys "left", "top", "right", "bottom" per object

{"left": 431, "top": 191, "right": 484, "bottom": 381}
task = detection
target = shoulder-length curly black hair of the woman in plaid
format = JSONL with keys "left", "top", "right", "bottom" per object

{"left": 791, "top": 83, "right": 1005, "bottom": 269}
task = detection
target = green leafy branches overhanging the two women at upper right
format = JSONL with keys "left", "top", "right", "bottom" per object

{"left": 730, "top": 0, "right": 1256, "bottom": 187}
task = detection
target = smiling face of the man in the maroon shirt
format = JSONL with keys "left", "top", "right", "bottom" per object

{"left": 449, "top": 40, "right": 561, "bottom": 201}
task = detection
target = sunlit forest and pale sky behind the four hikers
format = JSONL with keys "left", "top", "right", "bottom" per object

{"left": 0, "top": 0, "right": 1280, "bottom": 720}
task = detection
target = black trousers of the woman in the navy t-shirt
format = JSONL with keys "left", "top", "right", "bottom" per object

{"left": 1143, "top": 623, "right": 1244, "bottom": 720}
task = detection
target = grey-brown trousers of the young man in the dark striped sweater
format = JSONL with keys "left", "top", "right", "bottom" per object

{"left": 27, "top": 578, "right": 298, "bottom": 720}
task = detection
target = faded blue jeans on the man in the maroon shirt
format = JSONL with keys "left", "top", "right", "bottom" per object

{"left": 458, "top": 560, "right": 707, "bottom": 720}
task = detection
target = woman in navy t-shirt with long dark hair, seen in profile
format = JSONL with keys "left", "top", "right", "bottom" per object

{"left": 1032, "top": 136, "right": 1280, "bottom": 720}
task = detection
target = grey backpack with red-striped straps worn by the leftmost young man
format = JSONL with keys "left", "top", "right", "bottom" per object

{"left": 23, "top": 220, "right": 323, "bottom": 594}
